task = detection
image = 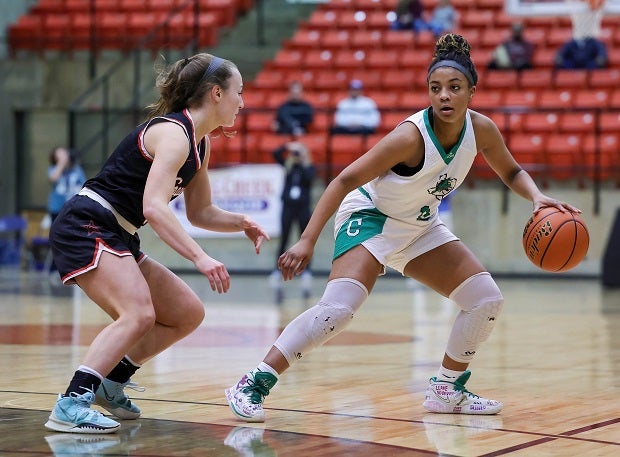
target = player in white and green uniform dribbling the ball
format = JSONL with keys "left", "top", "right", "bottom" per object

{"left": 226, "top": 34, "right": 579, "bottom": 422}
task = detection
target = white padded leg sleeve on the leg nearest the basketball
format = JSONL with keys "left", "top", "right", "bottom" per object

{"left": 446, "top": 272, "right": 504, "bottom": 363}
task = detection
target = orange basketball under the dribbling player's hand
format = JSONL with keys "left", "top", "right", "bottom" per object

{"left": 523, "top": 206, "right": 590, "bottom": 273}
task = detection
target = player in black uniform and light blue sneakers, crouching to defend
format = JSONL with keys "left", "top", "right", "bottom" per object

{"left": 45, "top": 53, "right": 269, "bottom": 433}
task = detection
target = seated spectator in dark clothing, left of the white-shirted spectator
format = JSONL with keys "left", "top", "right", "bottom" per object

{"left": 273, "top": 81, "right": 314, "bottom": 137}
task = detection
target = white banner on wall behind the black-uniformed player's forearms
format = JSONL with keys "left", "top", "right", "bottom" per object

{"left": 170, "top": 164, "right": 284, "bottom": 238}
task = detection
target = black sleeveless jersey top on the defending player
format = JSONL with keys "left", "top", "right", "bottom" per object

{"left": 84, "top": 110, "right": 206, "bottom": 227}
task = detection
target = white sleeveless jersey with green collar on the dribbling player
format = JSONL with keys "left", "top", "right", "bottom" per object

{"left": 354, "top": 108, "right": 478, "bottom": 227}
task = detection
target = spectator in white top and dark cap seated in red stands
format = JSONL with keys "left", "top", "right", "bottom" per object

{"left": 331, "top": 79, "right": 381, "bottom": 135}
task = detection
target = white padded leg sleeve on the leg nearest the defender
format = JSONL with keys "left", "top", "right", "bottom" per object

{"left": 273, "top": 278, "right": 368, "bottom": 365}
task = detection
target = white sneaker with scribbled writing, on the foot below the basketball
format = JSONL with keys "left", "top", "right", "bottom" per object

{"left": 422, "top": 370, "right": 504, "bottom": 414}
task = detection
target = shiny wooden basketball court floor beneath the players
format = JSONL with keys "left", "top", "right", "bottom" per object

{"left": 0, "top": 270, "right": 620, "bottom": 457}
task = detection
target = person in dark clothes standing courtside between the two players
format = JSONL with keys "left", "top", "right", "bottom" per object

{"left": 270, "top": 141, "right": 316, "bottom": 303}
